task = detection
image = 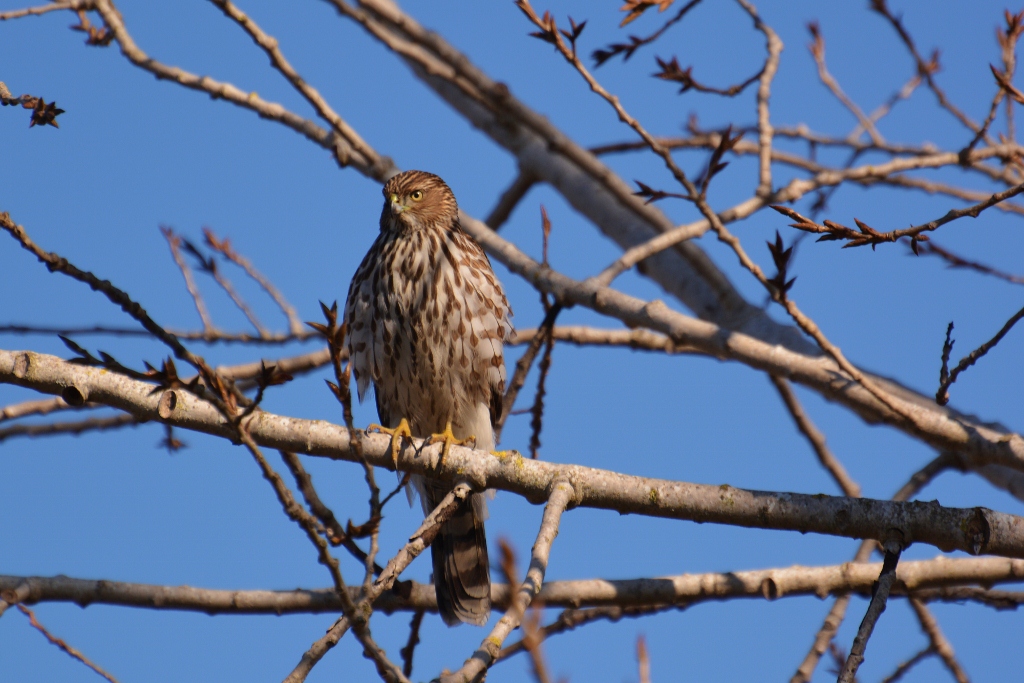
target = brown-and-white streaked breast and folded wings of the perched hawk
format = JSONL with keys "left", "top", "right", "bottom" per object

{"left": 345, "top": 228, "right": 512, "bottom": 435}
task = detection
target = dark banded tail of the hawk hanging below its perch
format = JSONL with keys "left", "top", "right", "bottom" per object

{"left": 425, "top": 480, "right": 490, "bottom": 626}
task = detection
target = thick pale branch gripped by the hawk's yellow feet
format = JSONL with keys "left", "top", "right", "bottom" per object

{"left": 0, "top": 351, "right": 1024, "bottom": 557}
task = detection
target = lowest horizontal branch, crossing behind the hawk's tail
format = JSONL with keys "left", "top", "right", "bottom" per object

{"left": 0, "top": 556, "right": 1024, "bottom": 614}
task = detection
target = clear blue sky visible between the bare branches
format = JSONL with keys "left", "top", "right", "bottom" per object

{"left": 0, "top": 0, "right": 1024, "bottom": 681}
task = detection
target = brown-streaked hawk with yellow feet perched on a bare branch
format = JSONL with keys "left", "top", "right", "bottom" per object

{"left": 345, "top": 171, "right": 512, "bottom": 626}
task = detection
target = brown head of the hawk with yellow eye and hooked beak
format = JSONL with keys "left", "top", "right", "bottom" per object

{"left": 381, "top": 171, "right": 459, "bottom": 232}
